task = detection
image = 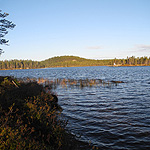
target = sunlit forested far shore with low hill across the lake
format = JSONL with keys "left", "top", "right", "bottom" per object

{"left": 0, "top": 56, "right": 150, "bottom": 69}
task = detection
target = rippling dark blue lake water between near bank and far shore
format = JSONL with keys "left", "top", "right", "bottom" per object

{"left": 0, "top": 66, "right": 150, "bottom": 150}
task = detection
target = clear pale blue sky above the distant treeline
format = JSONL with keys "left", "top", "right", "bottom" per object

{"left": 0, "top": 0, "right": 150, "bottom": 60}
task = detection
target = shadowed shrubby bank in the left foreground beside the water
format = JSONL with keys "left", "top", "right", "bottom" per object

{"left": 0, "top": 76, "right": 98, "bottom": 150}
